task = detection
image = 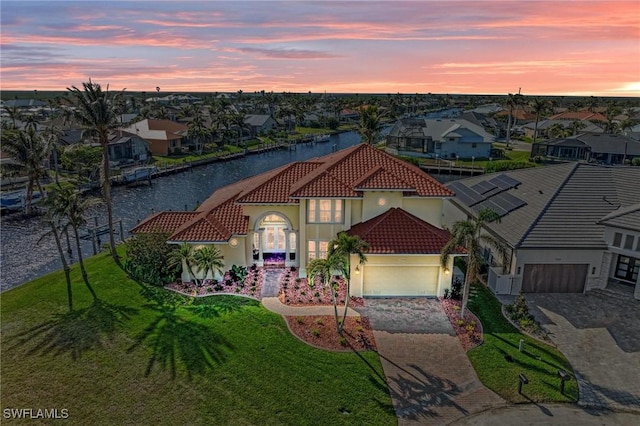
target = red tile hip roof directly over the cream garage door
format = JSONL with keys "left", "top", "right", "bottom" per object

{"left": 347, "top": 207, "right": 465, "bottom": 254}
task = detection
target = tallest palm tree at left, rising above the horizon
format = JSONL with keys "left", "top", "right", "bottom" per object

{"left": 67, "top": 79, "right": 124, "bottom": 266}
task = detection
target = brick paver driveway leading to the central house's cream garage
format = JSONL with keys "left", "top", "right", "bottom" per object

{"left": 358, "top": 298, "right": 506, "bottom": 425}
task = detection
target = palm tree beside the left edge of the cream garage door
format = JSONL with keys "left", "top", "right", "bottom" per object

{"left": 327, "top": 232, "right": 369, "bottom": 334}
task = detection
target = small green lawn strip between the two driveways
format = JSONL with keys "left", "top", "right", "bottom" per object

{"left": 467, "top": 284, "right": 578, "bottom": 403}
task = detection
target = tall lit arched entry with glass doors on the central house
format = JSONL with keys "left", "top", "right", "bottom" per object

{"left": 253, "top": 212, "right": 297, "bottom": 266}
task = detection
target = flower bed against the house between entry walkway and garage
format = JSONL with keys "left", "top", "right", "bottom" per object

{"left": 278, "top": 269, "right": 364, "bottom": 307}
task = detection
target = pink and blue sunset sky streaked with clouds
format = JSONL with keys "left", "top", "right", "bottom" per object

{"left": 0, "top": 0, "right": 640, "bottom": 96}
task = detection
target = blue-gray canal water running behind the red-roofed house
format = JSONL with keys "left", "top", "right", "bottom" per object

{"left": 0, "top": 132, "right": 361, "bottom": 291}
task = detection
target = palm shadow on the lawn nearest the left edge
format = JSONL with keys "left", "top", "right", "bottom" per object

{"left": 10, "top": 298, "right": 138, "bottom": 360}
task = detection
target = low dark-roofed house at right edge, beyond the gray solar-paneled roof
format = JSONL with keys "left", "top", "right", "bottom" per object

{"left": 531, "top": 133, "right": 640, "bottom": 164}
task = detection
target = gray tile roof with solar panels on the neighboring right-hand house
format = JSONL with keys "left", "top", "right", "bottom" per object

{"left": 444, "top": 163, "right": 640, "bottom": 249}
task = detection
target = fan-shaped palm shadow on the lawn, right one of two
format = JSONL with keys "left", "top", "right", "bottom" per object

{"left": 128, "top": 285, "right": 234, "bottom": 379}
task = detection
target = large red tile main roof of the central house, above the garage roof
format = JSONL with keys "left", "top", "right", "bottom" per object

{"left": 132, "top": 144, "right": 453, "bottom": 242}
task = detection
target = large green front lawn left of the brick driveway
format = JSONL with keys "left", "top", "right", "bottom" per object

{"left": 0, "top": 254, "right": 397, "bottom": 425}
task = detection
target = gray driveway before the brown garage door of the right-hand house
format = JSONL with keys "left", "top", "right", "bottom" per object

{"left": 526, "top": 293, "right": 640, "bottom": 413}
